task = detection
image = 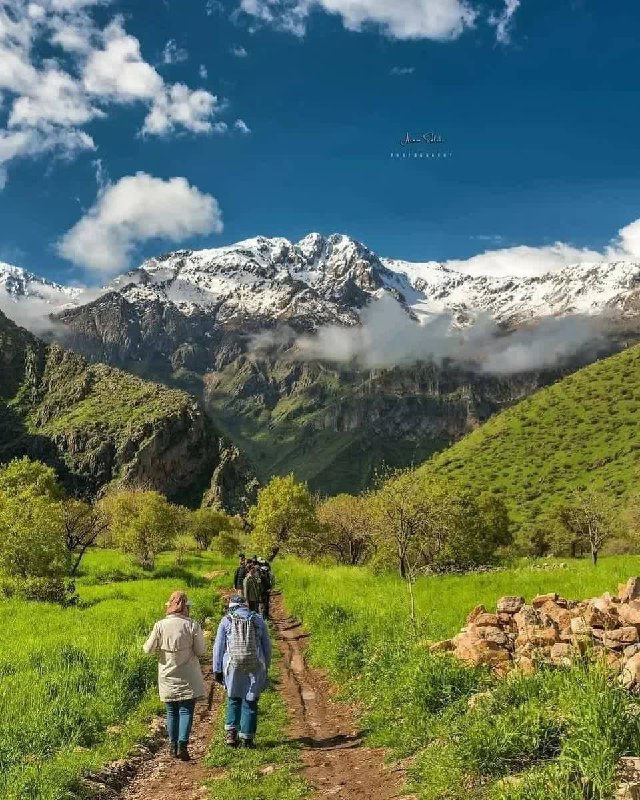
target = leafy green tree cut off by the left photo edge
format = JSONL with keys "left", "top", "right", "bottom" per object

{"left": 0, "top": 487, "right": 70, "bottom": 578}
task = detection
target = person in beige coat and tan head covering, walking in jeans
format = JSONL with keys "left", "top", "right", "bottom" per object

{"left": 143, "top": 592, "right": 206, "bottom": 761}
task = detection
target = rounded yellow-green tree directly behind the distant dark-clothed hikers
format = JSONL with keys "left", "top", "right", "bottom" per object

{"left": 249, "top": 475, "right": 318, "bottom": 558}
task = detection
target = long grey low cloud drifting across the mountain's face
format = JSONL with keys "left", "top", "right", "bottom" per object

{"left": 252, "top": 295, "right": 602, "bottom": 375}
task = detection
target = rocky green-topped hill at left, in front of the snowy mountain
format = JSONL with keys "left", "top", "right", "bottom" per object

{"left": 0, "top": 313, "right": 251, "bottom": 508}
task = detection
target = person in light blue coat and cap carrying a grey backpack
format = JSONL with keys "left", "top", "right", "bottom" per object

{"left": 213, "top": 595, "right": 271, "bottom": 747}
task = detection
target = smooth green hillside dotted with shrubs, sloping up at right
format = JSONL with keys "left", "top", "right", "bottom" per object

{"left": 420, "top": 346, "right": 640, "bottom": 523}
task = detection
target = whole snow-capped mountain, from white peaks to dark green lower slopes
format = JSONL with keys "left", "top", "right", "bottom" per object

{"left": 0, "top": 234, "right": 640, "bottom": 492}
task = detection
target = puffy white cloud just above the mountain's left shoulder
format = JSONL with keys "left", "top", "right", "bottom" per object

{"left": 58, "top": 172, "right": 223, "bottom": 274}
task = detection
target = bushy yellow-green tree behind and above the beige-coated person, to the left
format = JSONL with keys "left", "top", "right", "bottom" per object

{"left": 100, "top": 490, "right": 184, "bottom": 570}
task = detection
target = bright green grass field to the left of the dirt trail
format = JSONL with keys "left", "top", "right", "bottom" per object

{"left": 0, "top": 551, "right": 228, "bottom": 800}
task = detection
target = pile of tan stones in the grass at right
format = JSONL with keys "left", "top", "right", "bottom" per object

{"left": 431, "top": 578, "right": 640, "bottom": 688}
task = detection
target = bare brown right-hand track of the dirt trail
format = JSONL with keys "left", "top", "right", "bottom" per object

{"left": 273, "top": 595, "right": 409, "bottom": 800}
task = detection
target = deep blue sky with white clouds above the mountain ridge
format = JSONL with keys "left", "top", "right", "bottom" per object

{"left": 0, "top": 0, "right": 640, "bottom": 283}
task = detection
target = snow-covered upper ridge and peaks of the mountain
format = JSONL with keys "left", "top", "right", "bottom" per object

{"left": 0, "top": 233, "right": 640, "bottom": 328}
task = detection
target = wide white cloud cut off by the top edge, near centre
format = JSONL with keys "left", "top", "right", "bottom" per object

{"left": 240, "top": 0, "right": 476, "bottom": 41}
